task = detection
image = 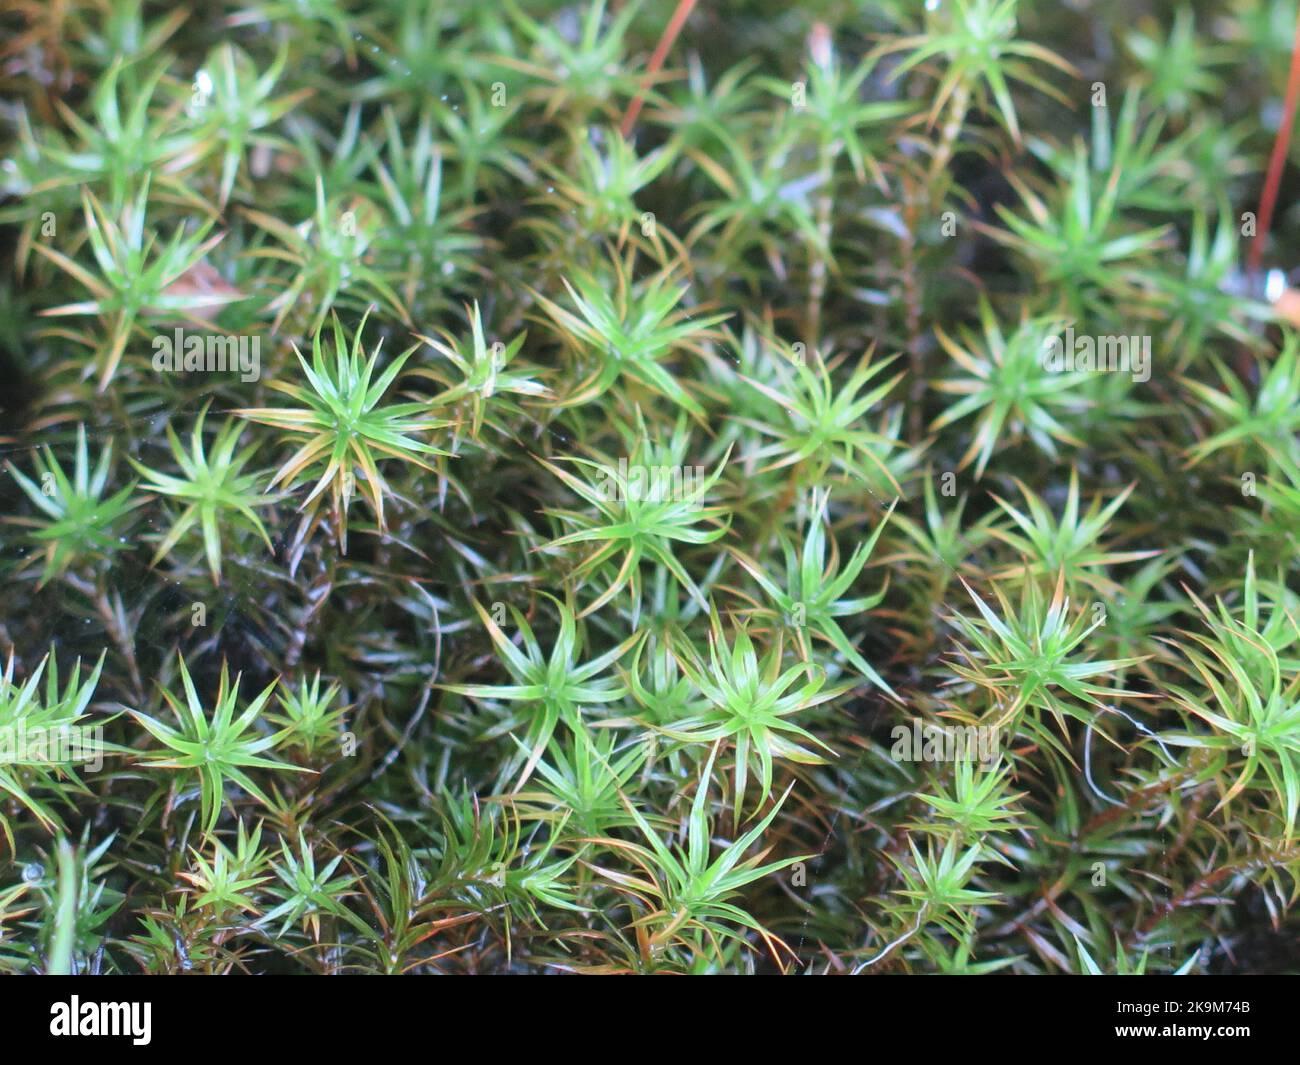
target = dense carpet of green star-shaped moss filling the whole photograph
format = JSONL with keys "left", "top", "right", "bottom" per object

{"left": 0, "top": 0, "right": 1300, "bottom": 973}
